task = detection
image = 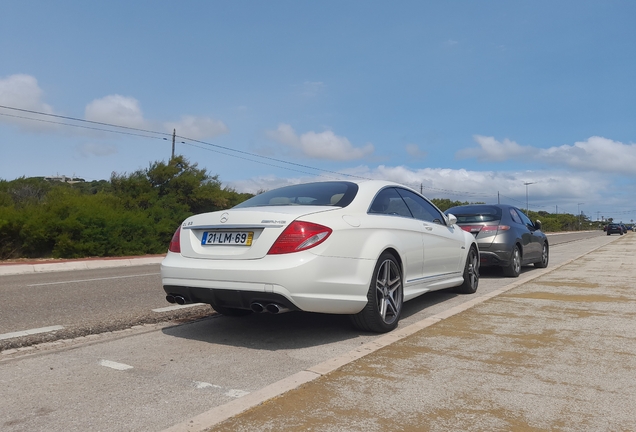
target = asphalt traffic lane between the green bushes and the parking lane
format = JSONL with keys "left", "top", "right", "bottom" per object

{"left": 0, "top": 231, "right": 602, "bottom": 350}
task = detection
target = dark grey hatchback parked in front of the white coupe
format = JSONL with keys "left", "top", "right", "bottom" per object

{"left": 446, "top": 204, "right": 550, "bottom": 277}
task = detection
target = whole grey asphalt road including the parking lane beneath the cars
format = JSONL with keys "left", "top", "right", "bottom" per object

{"left": 0, "top": 232, "right": 616, "bottom": 431}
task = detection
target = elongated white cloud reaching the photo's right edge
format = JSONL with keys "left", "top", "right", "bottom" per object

{"left": 456, "top": 135, "right": 636, "bottom": 176}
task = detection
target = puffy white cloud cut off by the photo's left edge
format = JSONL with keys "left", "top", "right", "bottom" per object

{"left": 0, "top": 74, "right": 55, "bottom": 130}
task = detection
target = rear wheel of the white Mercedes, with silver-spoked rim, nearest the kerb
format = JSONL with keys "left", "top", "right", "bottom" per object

{"left": 351, "top": 252, "right": 404, "bottom": 333}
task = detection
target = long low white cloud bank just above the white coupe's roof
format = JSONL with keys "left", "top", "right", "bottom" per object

{"left": 228, "top": 165, "right": 612, "bottom": 214}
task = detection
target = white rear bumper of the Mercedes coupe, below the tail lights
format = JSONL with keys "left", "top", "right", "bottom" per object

{"left": 161, "top": 252, "right": 376, "bottom": 314}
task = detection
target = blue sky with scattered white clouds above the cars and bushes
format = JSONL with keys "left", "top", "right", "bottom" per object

{"left": 0, "top": 0, "right": 636, "bottom": 222}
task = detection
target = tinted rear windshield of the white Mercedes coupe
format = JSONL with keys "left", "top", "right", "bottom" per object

{"left": 234, "top": 181, "right": 358, "bottom": 208}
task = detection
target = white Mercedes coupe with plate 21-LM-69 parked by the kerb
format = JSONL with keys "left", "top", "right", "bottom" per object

{"left": 161, "top": 180, "right": 479, "bottom": 333}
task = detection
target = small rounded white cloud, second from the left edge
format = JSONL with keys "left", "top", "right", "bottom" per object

{"left": 84, "top": 94, "right": 147, "bottom": 128}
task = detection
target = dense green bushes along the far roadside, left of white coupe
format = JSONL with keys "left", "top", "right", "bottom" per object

{"left": 0, "top": 156, "right": 251, "bottom": 259}
